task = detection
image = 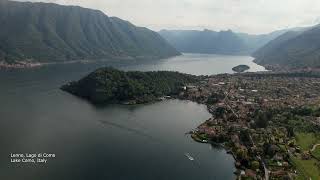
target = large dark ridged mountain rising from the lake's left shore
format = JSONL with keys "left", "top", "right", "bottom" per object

{"left": 0, "top": 0, "right": 180, "bottom": 63}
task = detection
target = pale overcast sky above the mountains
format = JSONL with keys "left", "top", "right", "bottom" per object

{"left": 16, "top": 0, "right": 320, "bottom": 34}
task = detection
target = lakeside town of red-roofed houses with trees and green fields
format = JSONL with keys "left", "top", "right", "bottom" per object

{"left": 179, "top": 71, "right": 320, "bottom": 179}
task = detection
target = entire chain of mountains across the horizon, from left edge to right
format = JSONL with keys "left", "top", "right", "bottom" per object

{"left": 0, "top": 0, "right": 320, "bottom": 68}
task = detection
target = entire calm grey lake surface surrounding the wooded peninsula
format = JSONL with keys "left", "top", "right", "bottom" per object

{"left": 0, "top": 54, "right": 264, "bottom": 180}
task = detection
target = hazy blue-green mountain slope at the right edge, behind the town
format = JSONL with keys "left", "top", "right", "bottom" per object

{"left": 253, "top": 26, "right": 320, "bottom": 68}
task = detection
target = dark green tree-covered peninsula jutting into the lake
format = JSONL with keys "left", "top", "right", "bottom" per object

{"left": 62, "top": 68, "right": 197, "bottom": 103}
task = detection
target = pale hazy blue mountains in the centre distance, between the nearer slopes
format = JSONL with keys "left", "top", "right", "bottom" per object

{"left": 159, "top": 30, "right": 287, "bottom": 55}
